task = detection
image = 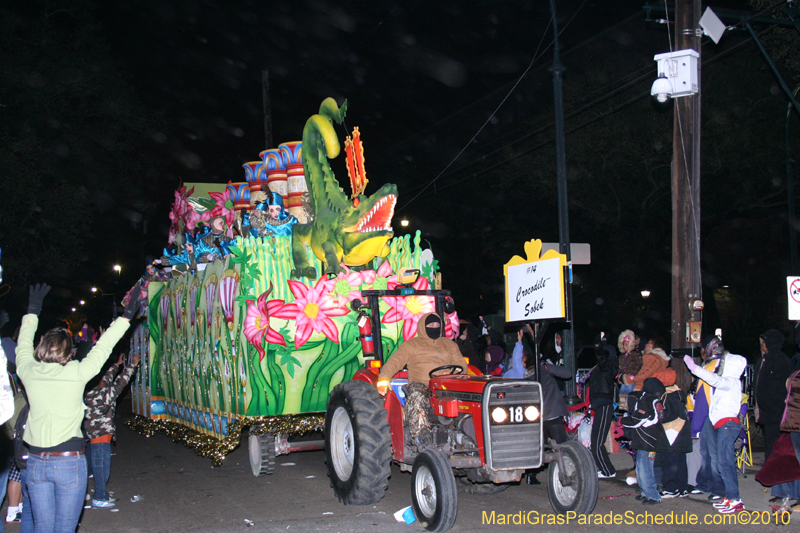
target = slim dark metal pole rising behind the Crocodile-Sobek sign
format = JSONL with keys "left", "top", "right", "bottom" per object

{"left": 550, "top": 0, "right": 578, "bottom": 405}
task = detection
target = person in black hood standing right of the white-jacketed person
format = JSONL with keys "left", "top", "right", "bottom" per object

{"left": 753, "top": 329, "right": 792, "bottom": 462}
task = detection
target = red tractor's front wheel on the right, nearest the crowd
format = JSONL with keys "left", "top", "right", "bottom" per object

{"left": 547, "top": 441, "right": 599, "bottom": 514}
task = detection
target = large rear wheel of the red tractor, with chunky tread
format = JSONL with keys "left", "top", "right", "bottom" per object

{"left": 325, "top": 381, "right": 392, "bottom": 505}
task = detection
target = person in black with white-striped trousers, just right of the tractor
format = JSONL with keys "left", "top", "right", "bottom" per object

{"left": 589, "top": 333, "right": 619, "bottom": 479}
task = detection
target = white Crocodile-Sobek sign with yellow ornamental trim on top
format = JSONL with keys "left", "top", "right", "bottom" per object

{"left": 505, "top": 241, "right": 566, "bottom": 322}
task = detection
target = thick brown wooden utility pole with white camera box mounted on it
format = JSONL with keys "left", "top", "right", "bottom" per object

{"left": 671, "top": 0, "right": 702, "bottom": 358}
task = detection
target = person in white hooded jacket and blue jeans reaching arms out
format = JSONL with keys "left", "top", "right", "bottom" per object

{"left": 683, "top": 351, "right": 747, "bottom": 514}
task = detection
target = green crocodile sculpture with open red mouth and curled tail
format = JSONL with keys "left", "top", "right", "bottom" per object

{"left": 292, "top": 98, "right": 397, "bottom": 279}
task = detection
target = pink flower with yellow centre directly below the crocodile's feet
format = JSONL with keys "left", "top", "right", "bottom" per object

{"left": 272, "top": 278, "right": 350, "bottom": 348}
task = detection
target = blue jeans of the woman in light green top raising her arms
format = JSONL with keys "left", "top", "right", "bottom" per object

{"left": 25, "top": 454, "right": 86, "bottom": 533}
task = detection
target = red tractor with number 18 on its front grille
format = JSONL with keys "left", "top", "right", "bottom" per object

{"left": 325, "top": 288, "right": 598, "bottom": 531}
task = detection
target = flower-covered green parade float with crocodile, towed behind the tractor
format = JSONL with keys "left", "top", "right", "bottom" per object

{"left": 128, "top": 98, "right": 458, "bottom": 475}
